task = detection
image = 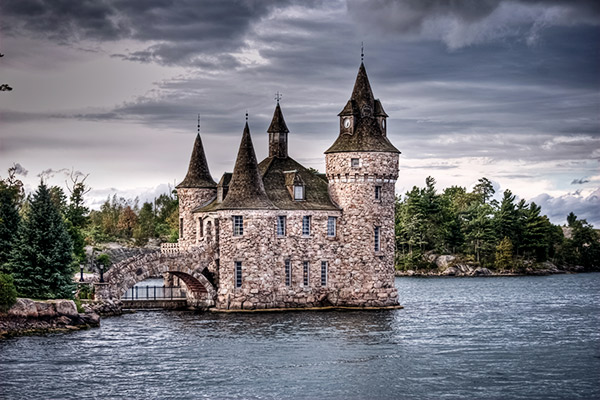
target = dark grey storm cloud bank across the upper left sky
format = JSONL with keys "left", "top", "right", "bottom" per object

{"left": 0, "top": 0, "right": 324, "bottom": 70}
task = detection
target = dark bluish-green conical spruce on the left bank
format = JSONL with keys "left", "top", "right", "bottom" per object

{"left": 8, "top": 182, "right": 75, "bottom": 298}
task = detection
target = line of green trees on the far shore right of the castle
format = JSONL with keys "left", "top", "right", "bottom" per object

{"left": 396, "top": 177, "right": 600, "bottom": 270}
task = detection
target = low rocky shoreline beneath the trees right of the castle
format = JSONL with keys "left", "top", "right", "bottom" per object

{"left": 396, "top": 253, "right": 586, "bottom": 277}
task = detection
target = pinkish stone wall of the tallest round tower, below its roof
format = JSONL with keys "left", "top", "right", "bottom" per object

{"left": 326, "top": 152, "right": 398, "bottom": 306}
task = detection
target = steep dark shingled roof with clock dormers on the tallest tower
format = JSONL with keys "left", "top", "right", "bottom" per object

{"left": 325, "top": 63, "right": 400, "bottom": 154}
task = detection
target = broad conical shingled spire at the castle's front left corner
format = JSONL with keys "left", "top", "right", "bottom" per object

{"left": 218, "top": 122, "right": 275, "bottom": 210}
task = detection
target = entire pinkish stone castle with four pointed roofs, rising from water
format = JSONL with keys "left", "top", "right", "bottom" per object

{"left": 177, "top": 63, "right": 400, "bottom": 310}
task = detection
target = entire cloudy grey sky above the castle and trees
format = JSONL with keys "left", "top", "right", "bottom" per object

{"left": 0, "top": 0, "right": 600, "bottom": 227}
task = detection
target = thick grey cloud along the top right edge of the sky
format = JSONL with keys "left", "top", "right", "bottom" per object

{"left": 348, "top": 0, "right": 600, "bottom": 49}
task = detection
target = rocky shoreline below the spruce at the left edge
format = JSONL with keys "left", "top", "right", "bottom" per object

{"left": 0, "top": 298, "right": 100, "bottom": 338}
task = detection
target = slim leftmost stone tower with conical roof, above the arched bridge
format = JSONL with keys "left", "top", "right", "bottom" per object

{"left": 176, "top": 126, "right": 217, "bottom": 248}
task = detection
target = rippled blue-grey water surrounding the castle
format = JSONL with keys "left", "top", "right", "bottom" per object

{"left": 0, "top": 274, "right": 600, "bottom": 399}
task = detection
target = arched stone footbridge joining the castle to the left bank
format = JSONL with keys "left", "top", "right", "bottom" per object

{"left": 95, "top": 249, "right": 217, "bottom": 308}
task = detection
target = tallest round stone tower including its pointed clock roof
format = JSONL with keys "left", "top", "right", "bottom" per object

{"left": 325, "top": 63, "right": 400, "bottom": 306}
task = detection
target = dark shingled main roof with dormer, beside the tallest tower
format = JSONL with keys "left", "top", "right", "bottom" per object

{"left": 258, "top": 157, "right": 339, "bottom": 210}
